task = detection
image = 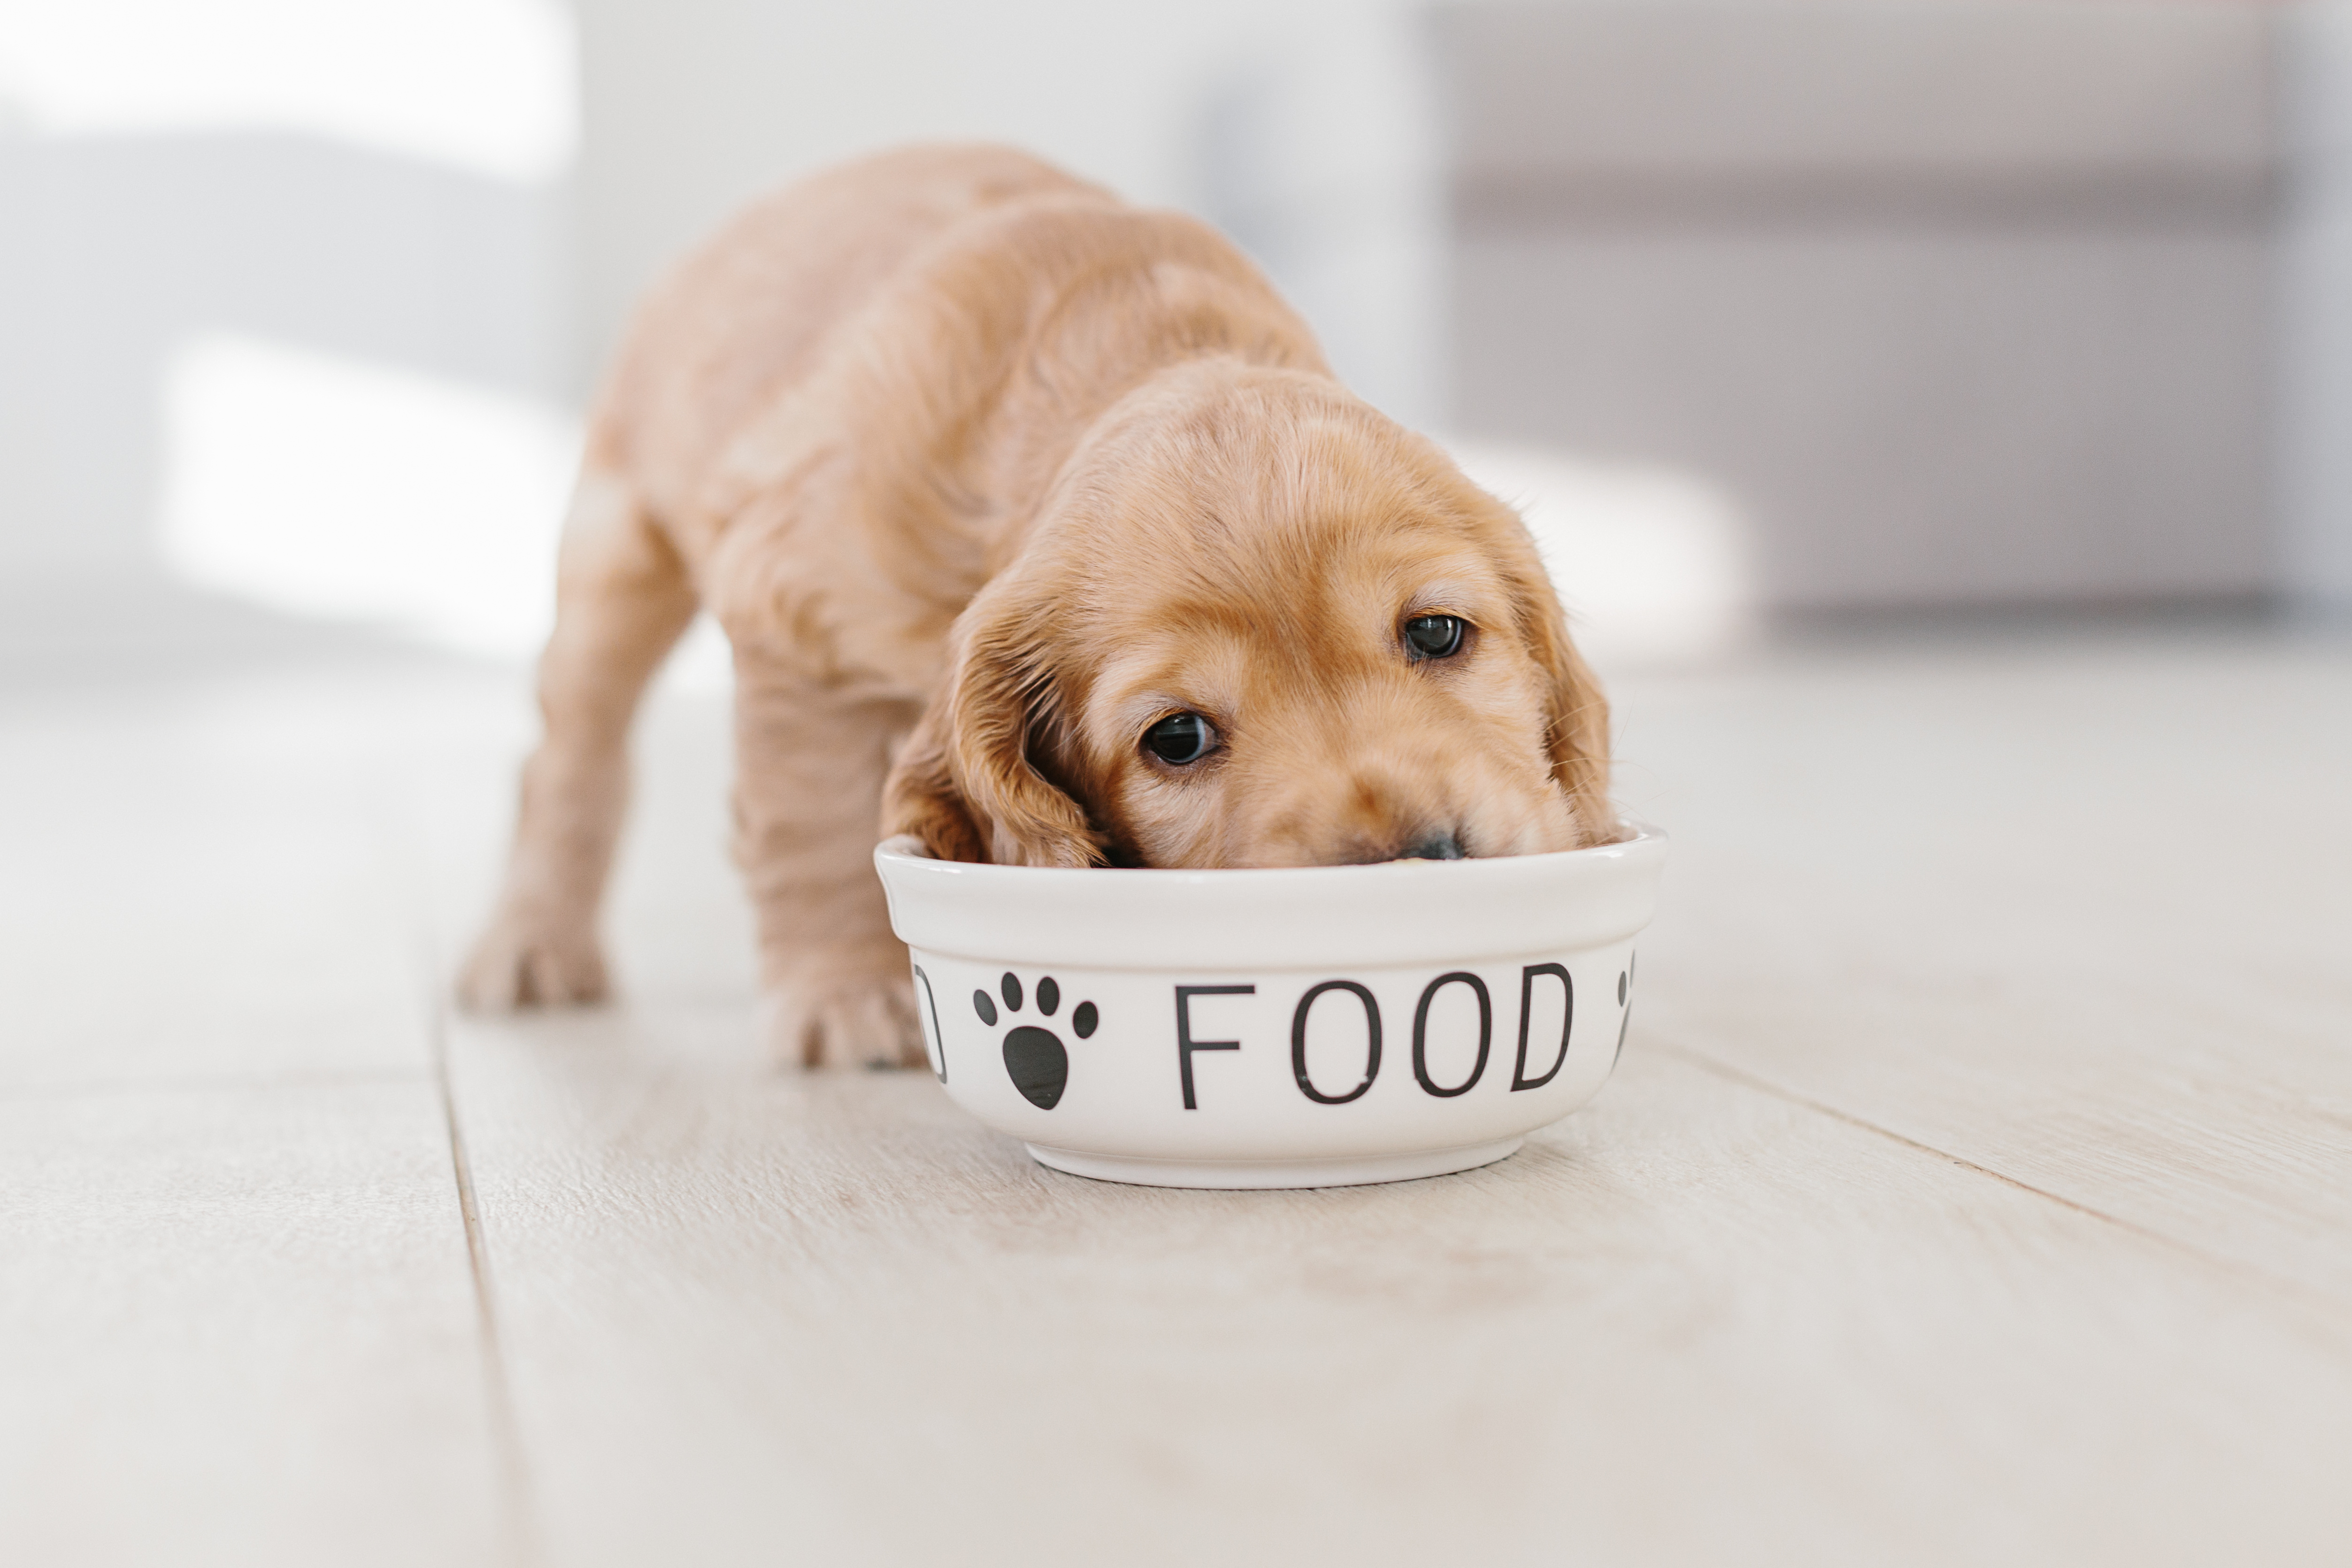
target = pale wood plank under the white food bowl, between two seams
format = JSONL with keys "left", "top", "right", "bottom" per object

{"left": 454, "top": 1008, "right": 2352, "bottom": 1566}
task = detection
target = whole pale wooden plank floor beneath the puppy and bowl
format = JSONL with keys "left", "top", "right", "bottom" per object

{"left": 0, "top": 630, "right": 2352, "bottom": 1568}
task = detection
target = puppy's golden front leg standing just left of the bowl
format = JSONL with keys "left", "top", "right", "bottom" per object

{"left": 736, "top": 651, "right": 922, "bottom": 1067}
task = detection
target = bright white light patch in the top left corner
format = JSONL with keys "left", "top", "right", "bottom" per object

{"left": 0, "top": 0, "right": 578, "bottom": 181}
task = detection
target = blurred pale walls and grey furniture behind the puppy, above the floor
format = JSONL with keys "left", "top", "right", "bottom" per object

{"left": 0, "top": 0, "right": 2352, "bottom": 672}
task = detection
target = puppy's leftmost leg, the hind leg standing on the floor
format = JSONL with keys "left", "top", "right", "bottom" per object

{"left": 459, "top": 468, "right": 694, "bottom": 1011}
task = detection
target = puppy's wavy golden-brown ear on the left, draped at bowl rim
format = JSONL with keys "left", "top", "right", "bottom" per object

{"left": 882, "top": 578, "right": 1103, "bottom": 865}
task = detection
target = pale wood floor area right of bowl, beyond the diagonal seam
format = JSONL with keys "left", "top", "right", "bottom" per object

{"left": 1618, "top": 635, "right": 2352, "bottom": 1300}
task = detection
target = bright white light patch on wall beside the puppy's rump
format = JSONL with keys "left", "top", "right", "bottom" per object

{"left": 162, "top": 336, "right": 578, "bottom": 656}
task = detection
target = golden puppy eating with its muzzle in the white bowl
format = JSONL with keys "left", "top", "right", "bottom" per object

{"left": 461, "top": 148, "right": 1611, "bottom": 1065}
